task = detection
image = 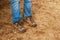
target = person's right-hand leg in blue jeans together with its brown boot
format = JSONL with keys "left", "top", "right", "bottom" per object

{"left": 24, "top": 0, "right": 37, "bottom": 27}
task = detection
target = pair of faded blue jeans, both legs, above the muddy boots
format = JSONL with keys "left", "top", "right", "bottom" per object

{"left": 11, "top": 0, "right": 32, "bottom": 23}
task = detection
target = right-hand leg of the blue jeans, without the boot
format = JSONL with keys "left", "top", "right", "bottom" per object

{"left": 24, "top": 0, "right": 32, "bottom": 18}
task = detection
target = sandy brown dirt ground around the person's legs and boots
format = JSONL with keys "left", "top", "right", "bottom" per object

{"left": 0, "top": 0, "right": 60, "bottom": 40}
